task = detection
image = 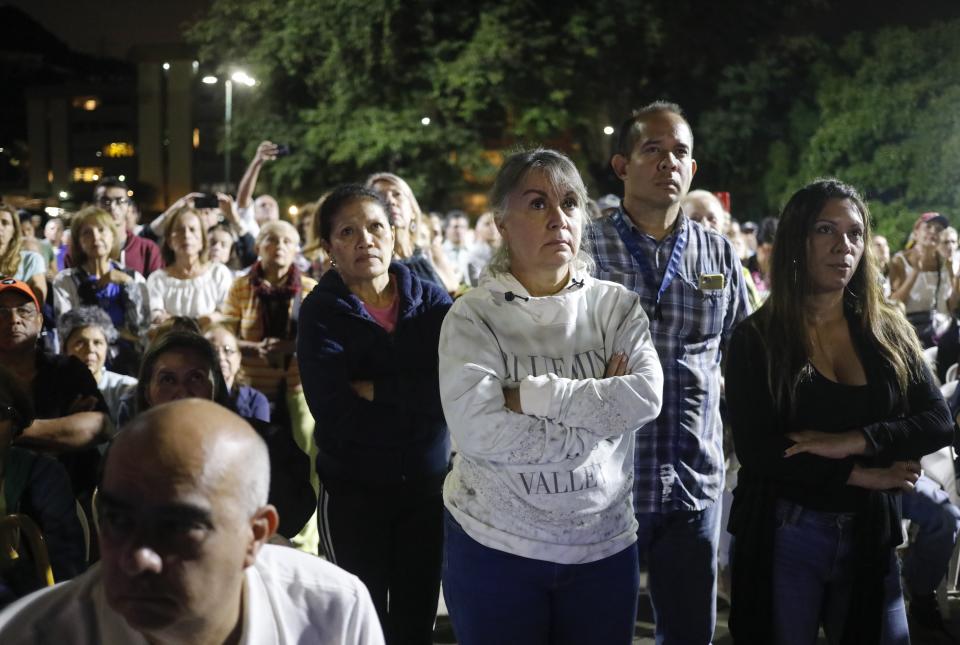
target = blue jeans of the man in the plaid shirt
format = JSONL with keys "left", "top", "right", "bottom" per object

{"left": 636, "top": 502, "right": 721, "bottom": 645}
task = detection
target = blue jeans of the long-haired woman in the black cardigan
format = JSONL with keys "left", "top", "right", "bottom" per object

{"left": 772, "top": 500, "right": 910, "bottom": 645}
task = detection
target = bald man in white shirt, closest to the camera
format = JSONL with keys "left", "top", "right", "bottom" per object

{"left": 0, "top": 399, "right": 384, "bottom": 645}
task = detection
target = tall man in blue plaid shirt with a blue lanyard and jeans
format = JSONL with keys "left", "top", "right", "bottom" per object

{"left": 588, "top": 101, "right": 748, "bottom": 645}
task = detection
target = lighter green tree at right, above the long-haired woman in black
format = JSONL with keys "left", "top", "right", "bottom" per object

{"left": 796, "top": 21, "right": 960, "bottom": 242}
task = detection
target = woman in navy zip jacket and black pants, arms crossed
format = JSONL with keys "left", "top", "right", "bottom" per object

{"left": 297, "top": 185, "right": 450, "bottom": 643}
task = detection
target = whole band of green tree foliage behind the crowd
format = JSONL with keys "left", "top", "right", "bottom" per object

{"left": 190, "top": 0, "right": 960, "bottom": 230}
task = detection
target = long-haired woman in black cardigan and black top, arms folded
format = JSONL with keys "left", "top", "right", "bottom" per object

{"left": 726, "top": 180, "right": 953, "bottom": 645}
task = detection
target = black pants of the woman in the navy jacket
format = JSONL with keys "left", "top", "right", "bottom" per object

{"left": 317, "top": 482, "right": 443, "bottom": 645}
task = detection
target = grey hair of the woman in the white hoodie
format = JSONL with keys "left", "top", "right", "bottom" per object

{"left": 487, "top": 148, "right": 594, "bottom": 274}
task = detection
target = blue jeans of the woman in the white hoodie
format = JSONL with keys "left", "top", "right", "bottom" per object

{"left": 443, "top": 513, "right": 640, "bottom": 645}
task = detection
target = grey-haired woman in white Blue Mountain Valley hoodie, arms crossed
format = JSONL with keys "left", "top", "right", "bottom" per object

{"left": 439, "top": 149, "right": 663, "bottom": 645}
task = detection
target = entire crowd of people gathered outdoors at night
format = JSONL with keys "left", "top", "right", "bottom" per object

{"left": 0, "top": 102, "right": 960, "bottom": 645}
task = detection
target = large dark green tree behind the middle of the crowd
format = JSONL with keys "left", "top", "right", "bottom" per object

{"left": 184, "top": 0, "right": 817, "bottom": 208}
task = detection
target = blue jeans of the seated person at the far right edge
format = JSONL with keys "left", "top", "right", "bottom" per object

{"left": 901, "top": 475, "right": 960, "bottom": 598}
